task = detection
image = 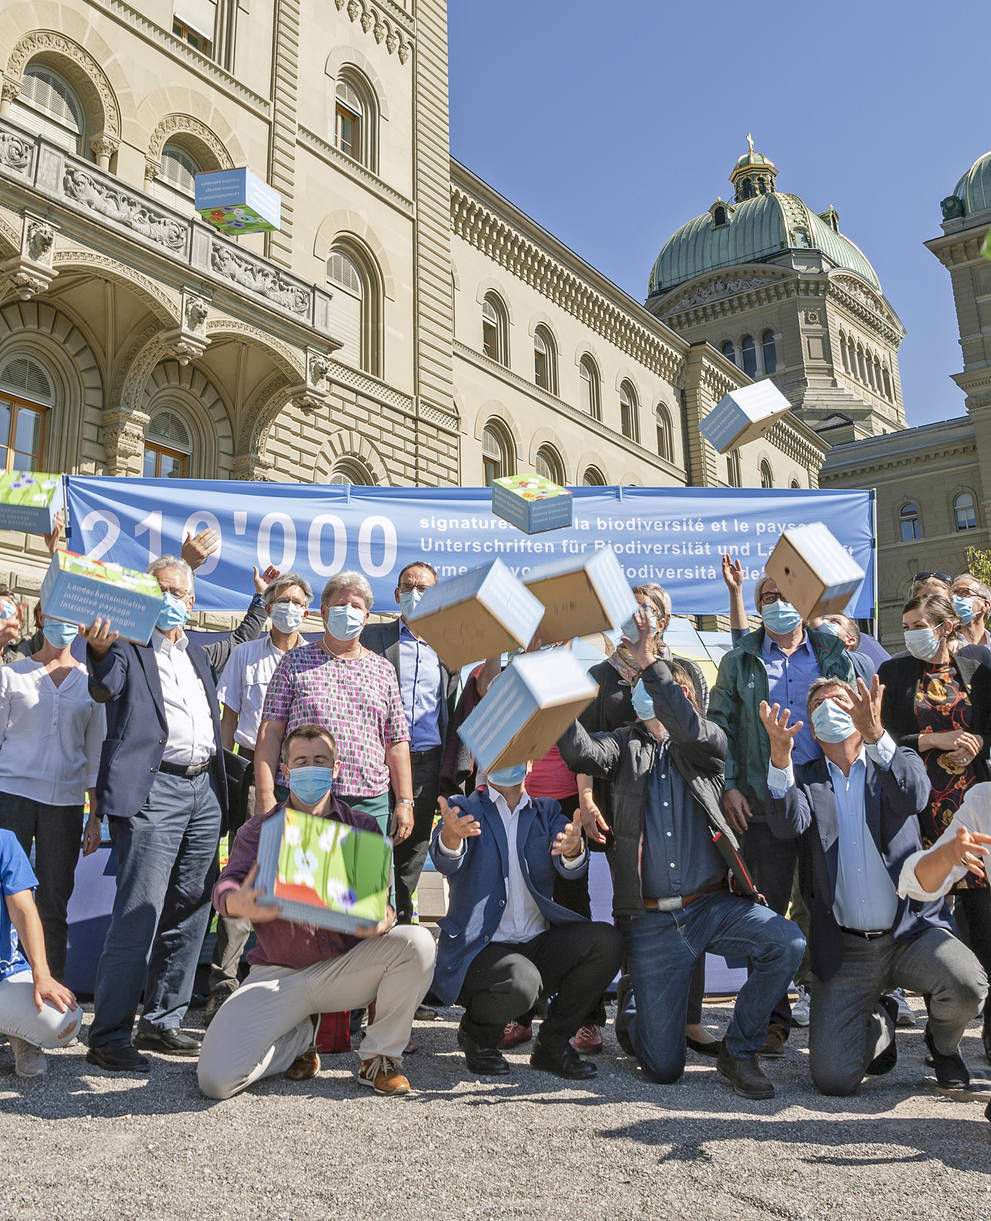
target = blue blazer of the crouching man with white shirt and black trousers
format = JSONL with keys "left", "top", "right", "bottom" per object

{"left": 430, "top": 789, "right": 588, "bottom": 1005}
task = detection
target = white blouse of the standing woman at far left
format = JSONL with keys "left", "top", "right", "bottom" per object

{"left": 0, "top": 657, "right": 106, "bottom": 806}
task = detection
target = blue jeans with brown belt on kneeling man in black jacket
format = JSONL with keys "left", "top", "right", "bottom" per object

{"left": 616, "top": 890, "right": 805, "bottom": 1083}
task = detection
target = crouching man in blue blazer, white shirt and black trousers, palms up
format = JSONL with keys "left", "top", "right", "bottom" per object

{"left": 430, "top": 764, "right": 622, "bottom": 1078}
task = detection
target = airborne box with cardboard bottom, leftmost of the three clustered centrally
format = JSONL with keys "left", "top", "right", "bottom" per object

{"left": 408, "top": 559, "right": 543, "bottom": 670}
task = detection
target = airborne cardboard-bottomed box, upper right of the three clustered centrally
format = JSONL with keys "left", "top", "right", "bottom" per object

{"left": 524, "top": 547, "right": 637, "bottom": 645}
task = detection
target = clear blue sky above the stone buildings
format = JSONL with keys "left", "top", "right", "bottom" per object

{"left": 449, "top": 0, "right": 991, "bottom": 424}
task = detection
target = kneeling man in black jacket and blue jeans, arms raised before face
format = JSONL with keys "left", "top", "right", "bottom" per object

{"left": 558, "top": 613, "right": 805, "bottom": 1099}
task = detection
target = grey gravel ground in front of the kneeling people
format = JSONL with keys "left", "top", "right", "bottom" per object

{"left": 0, "top": 999, "right": 991, "bottom": 1221}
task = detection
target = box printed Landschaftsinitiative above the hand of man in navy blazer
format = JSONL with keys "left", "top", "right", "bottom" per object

{"left": 41, "top": 551, "right": 162, "bottom": 645}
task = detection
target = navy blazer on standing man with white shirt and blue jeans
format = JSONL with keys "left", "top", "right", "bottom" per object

{"left": 87, "top": 600, "right": 266, "bottom": 828}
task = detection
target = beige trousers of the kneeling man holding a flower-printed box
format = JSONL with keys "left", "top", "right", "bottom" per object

{"left": 196, "top": 924, "right": 436, "bottom": 1098}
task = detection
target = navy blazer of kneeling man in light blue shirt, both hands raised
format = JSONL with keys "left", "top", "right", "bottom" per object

{"left": 765, "top": 746, "right": 953, "bottom": 979}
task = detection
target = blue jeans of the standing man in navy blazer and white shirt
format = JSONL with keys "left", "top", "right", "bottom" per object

{"left": 89, "top": 770, "right": 221, "bottom": 1048}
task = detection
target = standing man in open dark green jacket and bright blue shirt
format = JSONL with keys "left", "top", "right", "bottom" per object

{"left": 709, "top": 573, "right": 853, "bottom": 1056}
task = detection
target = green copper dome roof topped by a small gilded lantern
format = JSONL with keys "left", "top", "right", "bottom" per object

{"left": 648, "top": 139, "right": 881, "bottom": 297}
